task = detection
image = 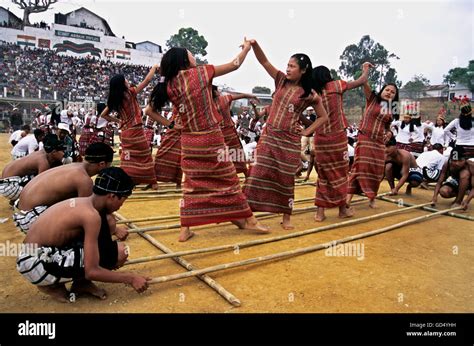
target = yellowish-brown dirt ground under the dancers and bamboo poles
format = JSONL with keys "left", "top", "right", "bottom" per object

{"left": 0, "top": 134, "right": 474, "bottom": 313}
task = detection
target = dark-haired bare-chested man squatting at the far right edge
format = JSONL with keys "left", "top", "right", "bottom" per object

{"left": 431, "top": 146, "right": 474, "bottom": 210}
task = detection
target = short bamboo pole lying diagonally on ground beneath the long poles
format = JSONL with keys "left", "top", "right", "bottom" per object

{"left": 115, "top": 212, "right": 241, "bottom": 307}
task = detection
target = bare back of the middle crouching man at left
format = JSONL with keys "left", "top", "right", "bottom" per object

{"left": 18, "top": 162, "right": 93, "bottom": 210}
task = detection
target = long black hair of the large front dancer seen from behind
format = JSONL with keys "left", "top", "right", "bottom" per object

{"left": 148, "top": 47, "right": 189, "bottom": 111}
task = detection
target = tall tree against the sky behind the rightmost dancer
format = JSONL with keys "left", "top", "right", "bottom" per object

{"left": 339, "top": 35, "right": 401, "bottom": 109}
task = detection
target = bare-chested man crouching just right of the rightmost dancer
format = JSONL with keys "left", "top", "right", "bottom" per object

{"left": 385, "top": 138, "right": 423, "bottom": 195}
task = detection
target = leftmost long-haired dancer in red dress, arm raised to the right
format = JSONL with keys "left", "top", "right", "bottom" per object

{"left": 100, "top": 65, "right": 159, "bottom": 189}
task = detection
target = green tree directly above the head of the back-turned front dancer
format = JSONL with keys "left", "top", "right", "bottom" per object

{"left": 166, "top": 28, "right": 208, "bottom": 64}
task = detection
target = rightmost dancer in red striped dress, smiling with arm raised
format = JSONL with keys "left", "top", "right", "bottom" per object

{"left": 347, "top": 83, "right": 399, "bottom": 208}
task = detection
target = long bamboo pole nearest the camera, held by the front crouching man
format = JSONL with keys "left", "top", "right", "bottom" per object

{"left": 148, "top": 207, "right": 461, "bottom": 284}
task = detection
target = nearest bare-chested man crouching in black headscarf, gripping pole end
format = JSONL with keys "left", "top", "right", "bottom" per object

{"left": 16, "top": 167, "right": 149, "bottom": 302}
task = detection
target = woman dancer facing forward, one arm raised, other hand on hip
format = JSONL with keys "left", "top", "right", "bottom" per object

{"left": 243, "top": 41, "right": 328, "bottom": 229}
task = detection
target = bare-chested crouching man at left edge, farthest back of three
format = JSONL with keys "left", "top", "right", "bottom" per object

{"left": 0, "top": 134, "right": 64, "bottom": 202}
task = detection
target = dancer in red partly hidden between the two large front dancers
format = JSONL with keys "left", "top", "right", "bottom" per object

{"left": 212, "top": 85, "right": 258, "bottom": 176}
